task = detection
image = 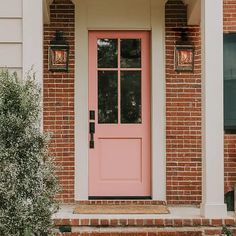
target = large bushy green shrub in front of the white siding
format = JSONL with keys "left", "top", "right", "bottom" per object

{"left": 0, "top": 71, "right": 58, "bottom": 236}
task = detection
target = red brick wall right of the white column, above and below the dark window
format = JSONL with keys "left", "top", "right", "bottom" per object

{"left": 224, "top": 0, "right": 236, "bottom": 192}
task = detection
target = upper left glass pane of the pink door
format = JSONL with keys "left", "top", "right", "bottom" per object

{"left": 97, "top": 39, "right": 118, "bottom": 68}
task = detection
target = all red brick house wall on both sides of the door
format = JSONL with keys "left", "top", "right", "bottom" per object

{"left": 41, "top": 0, "right": 236, "bottom": 204}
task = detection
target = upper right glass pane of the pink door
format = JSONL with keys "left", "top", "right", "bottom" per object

{"left": 120, "top": 39, "right": 141, "bottom": 68}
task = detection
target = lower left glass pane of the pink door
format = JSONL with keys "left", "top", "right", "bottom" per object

{"left": 98, "top": 71, "right": 118, "bottom": 123}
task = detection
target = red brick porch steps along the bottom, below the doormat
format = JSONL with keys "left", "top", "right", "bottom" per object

{"left": 55, "top": 218, "right": 236, "bottom": 236}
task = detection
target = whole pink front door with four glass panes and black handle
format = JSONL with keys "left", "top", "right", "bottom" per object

{"left": 89, "top": 31, "right": 151, "bottom": 197}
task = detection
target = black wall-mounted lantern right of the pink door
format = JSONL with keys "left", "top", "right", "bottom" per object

{"left": 174, "top": 27, "right": 194, "bottom": 72}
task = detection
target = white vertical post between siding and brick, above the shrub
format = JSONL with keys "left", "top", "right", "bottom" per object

{"left": 22, "top": 0, "right": 43, "bottom": 85}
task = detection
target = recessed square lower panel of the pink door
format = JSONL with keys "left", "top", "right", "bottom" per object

{"left": 98, "top": 138, "right": 142, "bottom": 181}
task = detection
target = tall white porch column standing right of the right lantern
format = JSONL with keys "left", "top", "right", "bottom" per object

{"left": 201, "top": 0, "right": 227, "bottom": 218}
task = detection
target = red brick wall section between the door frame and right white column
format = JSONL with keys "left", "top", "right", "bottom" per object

{"left": 165, "top": 0, "right": 202, "bottom": 204}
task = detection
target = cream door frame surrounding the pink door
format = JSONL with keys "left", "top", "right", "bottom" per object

{"left": 74, "top": 0, "right": 166, "bottom": 201}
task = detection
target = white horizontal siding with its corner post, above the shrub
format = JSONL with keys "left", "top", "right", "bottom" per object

{"left": 0, "top": 0, "right": 43, "bottom": 83}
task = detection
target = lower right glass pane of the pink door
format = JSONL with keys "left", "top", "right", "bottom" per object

{"left": 121, "top": 71, "right": 142, "bottom": 123}
